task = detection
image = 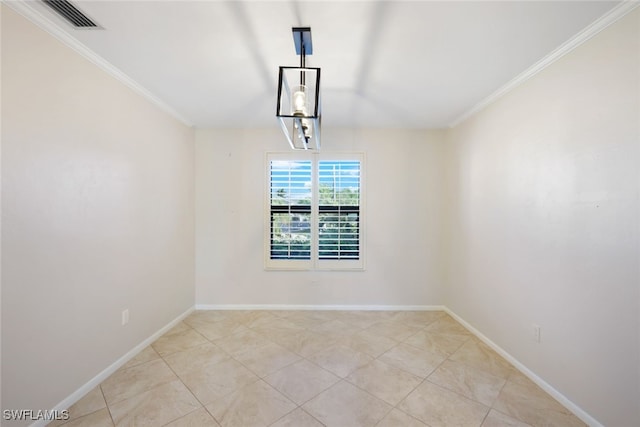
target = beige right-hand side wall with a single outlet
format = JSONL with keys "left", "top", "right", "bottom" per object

{"left": 447, "top": 10, "right": 640, "bottom": 426}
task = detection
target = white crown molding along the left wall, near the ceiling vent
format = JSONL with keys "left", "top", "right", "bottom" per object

{"left": 0, "top": 0, "right": 193, "bottom": 127}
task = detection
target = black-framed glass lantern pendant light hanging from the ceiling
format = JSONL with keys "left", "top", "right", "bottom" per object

{"left": 276, "top": 27, "right": 321, "bottom": 150}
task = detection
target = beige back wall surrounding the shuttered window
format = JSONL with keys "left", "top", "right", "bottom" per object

{"left": 196, "top": 129, "right": 444, "bottom": 307}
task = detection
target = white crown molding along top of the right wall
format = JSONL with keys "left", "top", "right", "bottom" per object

{"left": 448, "top": 0, "right": 640, "bottom": 128}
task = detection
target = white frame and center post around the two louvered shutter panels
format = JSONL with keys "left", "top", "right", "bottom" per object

{"left": 264, "top": 150, "right": 366, "bottom": 271}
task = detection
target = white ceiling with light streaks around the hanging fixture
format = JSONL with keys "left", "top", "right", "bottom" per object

{"left": 13, "top": 0, "right": 617, "bottom": 128}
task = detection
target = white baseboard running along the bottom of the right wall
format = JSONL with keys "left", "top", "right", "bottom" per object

{"left": 444, "top": 307, "right": 604, "bottom": 427}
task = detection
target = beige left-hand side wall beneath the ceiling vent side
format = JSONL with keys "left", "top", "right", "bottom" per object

{"left": 2, "top": 7, "right": 194, "bottom": 422}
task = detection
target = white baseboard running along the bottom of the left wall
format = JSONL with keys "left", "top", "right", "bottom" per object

{"left": 31, "top": 307, "right": 194, "bottom": 427}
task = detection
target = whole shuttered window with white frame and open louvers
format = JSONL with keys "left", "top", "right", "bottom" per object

{"left": 265, "top": 152, "right": 364, "bottom": 269}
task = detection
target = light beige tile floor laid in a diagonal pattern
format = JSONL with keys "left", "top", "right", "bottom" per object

{"left": 52, "top": 311, "right": 584, "bottom": 427}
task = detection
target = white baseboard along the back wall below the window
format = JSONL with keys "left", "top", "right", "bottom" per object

{"left": 196, "top": 304, "right": 445, "bottom": 311}
